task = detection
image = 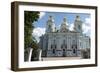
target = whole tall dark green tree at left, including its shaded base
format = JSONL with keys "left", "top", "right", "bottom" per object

{"left": 24, "top": 11, "right": 39, "bottom": 61}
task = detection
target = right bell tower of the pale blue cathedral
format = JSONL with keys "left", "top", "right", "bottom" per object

{"left": 74, "top": 16, "right": 82, "bottom": 34}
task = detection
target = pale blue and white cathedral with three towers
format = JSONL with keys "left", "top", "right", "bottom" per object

{"left": 39, "top": 16, "right": 90, "bottom": 57}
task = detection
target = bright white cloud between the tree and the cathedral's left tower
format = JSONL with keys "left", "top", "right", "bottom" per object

{"left": 32, "top": 27, "right": 46, "bottom": 42}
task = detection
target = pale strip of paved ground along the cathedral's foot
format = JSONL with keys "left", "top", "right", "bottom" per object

{"left": 42, "top": 57, "right": 81, "bottom": 61}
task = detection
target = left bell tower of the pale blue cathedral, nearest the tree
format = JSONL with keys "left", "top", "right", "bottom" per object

{"left": 46, "top": 16, "right": 55, "bottom": 32}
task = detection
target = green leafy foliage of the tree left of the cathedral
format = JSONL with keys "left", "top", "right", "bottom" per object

{"left": 24, "top": 11, "right": 39, "bottom": 49}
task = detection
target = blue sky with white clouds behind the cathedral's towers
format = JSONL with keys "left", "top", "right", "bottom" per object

{"left": 32, "top": 12, "right": 91, "bottom": 42}
